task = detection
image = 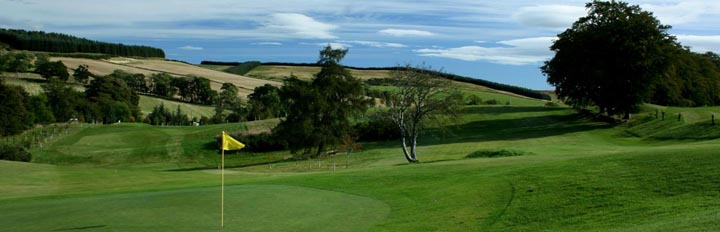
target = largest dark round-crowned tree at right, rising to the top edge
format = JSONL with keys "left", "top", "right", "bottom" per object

{"left": 541, "top": 1, "right": 678, "bottom": 118}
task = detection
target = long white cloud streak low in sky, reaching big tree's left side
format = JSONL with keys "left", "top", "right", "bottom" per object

{"left": 415, "top": 37, "right": 556, "bottom": 65}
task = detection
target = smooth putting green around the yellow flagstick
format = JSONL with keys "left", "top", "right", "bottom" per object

{"left": 0, "top": 185, "right": 390, "bottom": 231}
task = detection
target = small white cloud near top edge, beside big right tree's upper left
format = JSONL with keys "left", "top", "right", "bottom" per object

{"left": 513, "top": 5, "right": 586, "bottom": 29}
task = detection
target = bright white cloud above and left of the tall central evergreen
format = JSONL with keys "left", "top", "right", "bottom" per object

{"left": 263, "top": 13, "right": 337, "bottom": 39}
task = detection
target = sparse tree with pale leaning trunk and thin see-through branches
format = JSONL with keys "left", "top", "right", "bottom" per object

{"left": 384, "top": 66, "right": 463, "bottom": 163}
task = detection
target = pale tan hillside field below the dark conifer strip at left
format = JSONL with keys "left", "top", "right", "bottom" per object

{"left": 51, "top": 57, "right": 280, "bottom": 95}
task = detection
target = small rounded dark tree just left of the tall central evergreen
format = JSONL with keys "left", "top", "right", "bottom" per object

{"left": 247, "top": 84, "right": 286, "bottom": 120}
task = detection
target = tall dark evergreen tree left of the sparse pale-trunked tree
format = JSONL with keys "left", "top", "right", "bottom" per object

{"left": 274, "top": 46, "right": 372, "bottom": 156}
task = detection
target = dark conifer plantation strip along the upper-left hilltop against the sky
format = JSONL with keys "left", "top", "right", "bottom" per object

{"left": 0, "top": 29, "right": 165, "bottom": 58}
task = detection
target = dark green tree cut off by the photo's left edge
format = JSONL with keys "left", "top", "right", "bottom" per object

{"left": 0, "top": 79, "right": 33, "bottom": 136}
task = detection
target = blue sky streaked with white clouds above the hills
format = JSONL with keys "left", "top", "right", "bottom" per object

{"left": 0, "top": 0, "right": 720, "bottom": 90}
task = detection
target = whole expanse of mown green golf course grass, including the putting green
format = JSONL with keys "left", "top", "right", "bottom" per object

{"left": 0, "top": 86, "right": 720, "bottom": 231}
